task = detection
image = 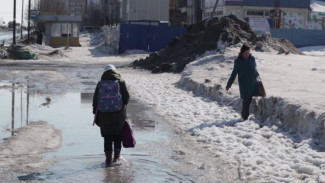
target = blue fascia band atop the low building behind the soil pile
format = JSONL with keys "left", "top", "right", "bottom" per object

{"left": 225, "top": 0, "right": 310, "bottom": 8}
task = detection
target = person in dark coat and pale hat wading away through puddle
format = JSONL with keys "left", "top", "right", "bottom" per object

{"left": 93, "top": 64, "right": 130, "bottom": 166}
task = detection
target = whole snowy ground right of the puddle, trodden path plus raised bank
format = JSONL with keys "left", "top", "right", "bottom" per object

{"left": 122, "top": 46, "right": 325, "bottom": 183}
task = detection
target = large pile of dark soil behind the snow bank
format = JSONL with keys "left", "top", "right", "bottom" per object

{"left": 132, "top": 15, "right": 302, "bottom": 73}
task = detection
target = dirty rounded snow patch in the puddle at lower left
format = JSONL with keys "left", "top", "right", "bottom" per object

{"left": 0, "top": 121, "right": 62, "bottom": 178}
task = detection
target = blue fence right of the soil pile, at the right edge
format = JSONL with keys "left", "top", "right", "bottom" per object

{"left": 271, "top": 29, "right": 325, "bottom": 47}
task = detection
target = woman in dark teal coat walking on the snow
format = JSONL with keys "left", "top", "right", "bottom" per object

{"left": 226, "top": 43, "right": 259, "bottom": 120}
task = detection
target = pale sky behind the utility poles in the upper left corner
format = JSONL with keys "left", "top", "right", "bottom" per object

{"left": 0, "top": 0, "right": 28, "bottom": 24}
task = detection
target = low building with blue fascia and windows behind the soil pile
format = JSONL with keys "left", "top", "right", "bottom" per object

{"left": 202, "top": 0, "right": 310, "bottom": 29}
